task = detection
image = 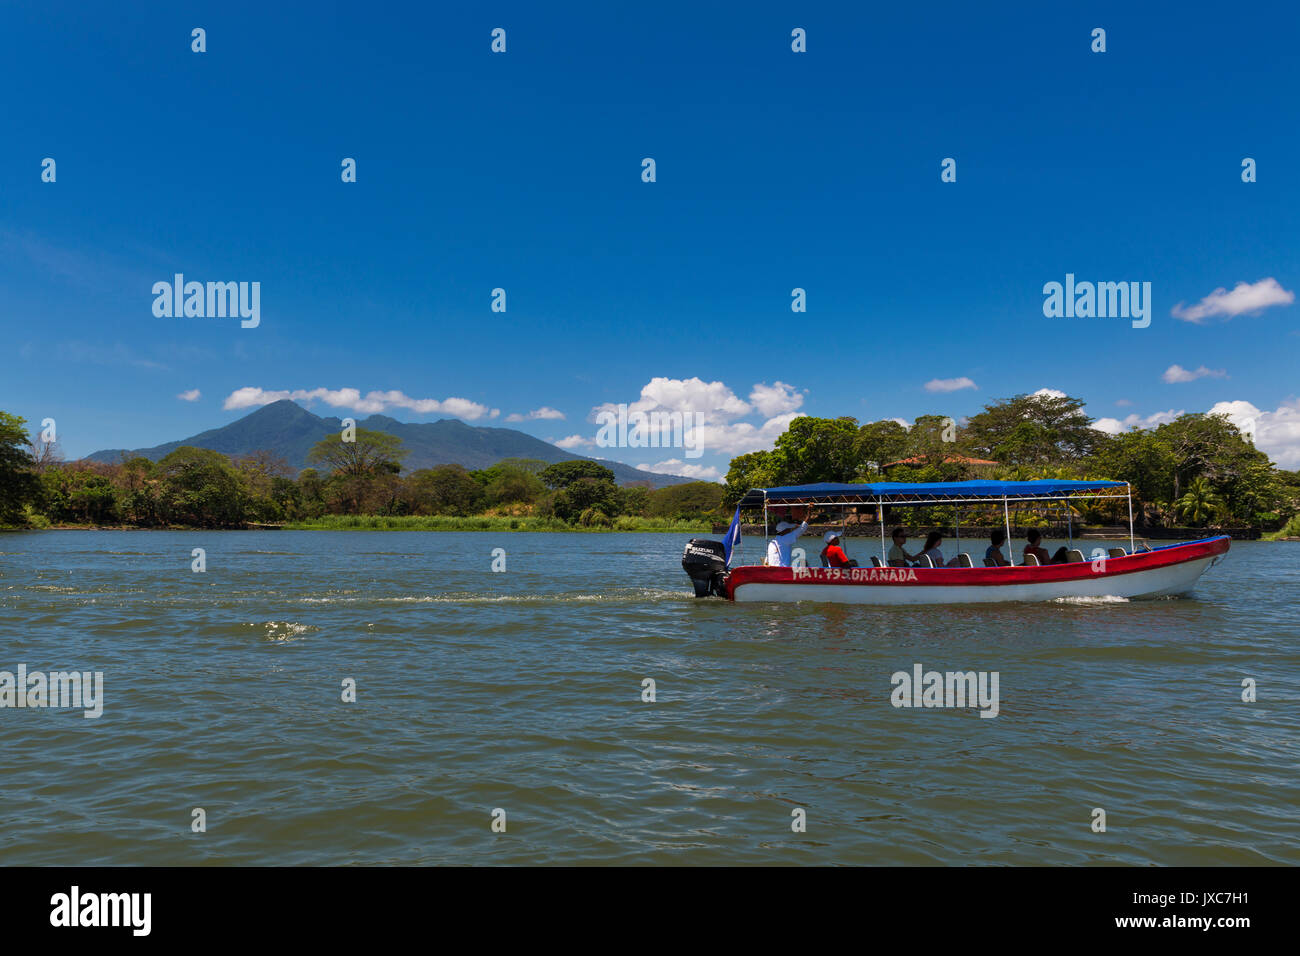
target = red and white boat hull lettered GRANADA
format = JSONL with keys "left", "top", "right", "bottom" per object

{"left": 727, "top": 537, "right": 1230, "bottom": 605}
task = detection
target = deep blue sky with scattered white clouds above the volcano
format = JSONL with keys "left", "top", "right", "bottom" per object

{"left": 0, "top": 3, "right": 1300, "bottom": 476}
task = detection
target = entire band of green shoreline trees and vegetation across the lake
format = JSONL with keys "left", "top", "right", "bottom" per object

{"left": 0, "top": 393, "right": 1300, "bottom": 541}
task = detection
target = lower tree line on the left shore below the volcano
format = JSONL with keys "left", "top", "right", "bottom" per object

{"left": 0, "top": 412, "right": 723, "bottom": 528}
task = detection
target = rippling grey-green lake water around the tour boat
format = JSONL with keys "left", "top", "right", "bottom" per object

{"left": 0, "top": 531, "right": 1300, "bottom": 865}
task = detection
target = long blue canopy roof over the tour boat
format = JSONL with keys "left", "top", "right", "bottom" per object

{"left": 740, "top": 479, "right": 1128, "bottom": 507}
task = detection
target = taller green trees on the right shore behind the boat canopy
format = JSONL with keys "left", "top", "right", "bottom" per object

{"left": 725, "top": 394, "right": 1300, "bottom": 529}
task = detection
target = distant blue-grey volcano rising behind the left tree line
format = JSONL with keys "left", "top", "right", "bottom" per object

{"left": 87, "top": 399, "right": 692, "bottom": 488}
